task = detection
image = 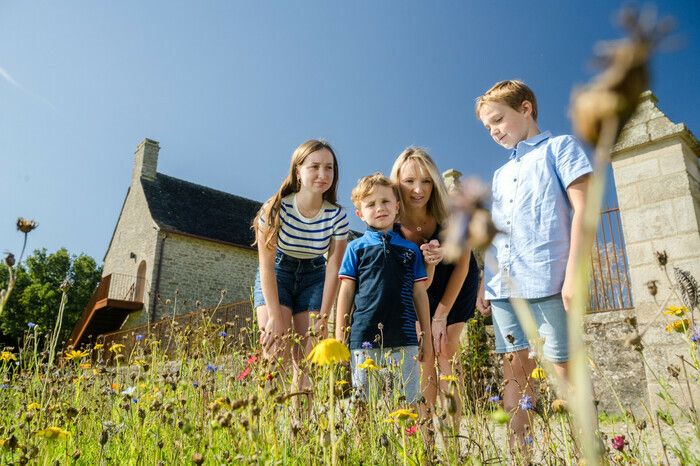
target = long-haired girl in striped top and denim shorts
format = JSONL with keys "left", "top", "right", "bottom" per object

{"left": 253, "top": 139, "right": 349, "bottom": 374}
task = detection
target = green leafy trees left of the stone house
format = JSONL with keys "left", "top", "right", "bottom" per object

{"left": 0, "top": 248, "right": 102, "bottom": 348}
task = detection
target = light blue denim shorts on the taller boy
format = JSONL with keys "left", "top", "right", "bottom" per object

{"left": 491, "top": 293, "right": 569, "bottom": 362}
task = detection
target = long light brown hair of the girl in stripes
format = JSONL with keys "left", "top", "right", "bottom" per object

{"left": 251, "top": 139, "right": 338, "bottom": 248}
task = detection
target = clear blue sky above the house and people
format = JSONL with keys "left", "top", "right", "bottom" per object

{"left": 0, "top": 0, "right": 700, "bottom": 262}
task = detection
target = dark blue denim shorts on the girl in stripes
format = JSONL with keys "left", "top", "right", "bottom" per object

{"left": 253, "top": 249, "right": 326, "bottom": 315}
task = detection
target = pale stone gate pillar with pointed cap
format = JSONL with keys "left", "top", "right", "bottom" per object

{"left": 612, "top": 91, "right": 700, "bottom": 404}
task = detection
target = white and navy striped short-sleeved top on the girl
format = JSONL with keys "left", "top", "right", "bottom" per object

{"left": 260, "top": 193, "right": 350, "bottom": 259}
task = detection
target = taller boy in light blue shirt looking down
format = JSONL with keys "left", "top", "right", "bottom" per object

{"left": 476, "top": 81, "right": 592, "bottom": 449}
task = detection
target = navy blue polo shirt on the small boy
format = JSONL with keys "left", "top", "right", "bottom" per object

{"left": 338, "top": 228, "right": 428, "bottom": 349}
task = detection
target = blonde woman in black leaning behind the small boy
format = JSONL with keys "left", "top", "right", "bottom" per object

{"left": 391, "top": 147, "right": 479, "bottom": 428}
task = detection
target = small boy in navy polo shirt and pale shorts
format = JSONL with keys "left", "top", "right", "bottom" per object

{"left": 335, "top": 173, "right": 432, "bottom": 403}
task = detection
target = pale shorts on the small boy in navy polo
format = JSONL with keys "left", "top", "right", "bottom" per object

{"left": 350, "top": 346, "right": 421, "bottom": 403}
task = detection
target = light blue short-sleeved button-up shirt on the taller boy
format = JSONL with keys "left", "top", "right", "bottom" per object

{"left": 484, "top": 131, "right": 592, "bottom": 299}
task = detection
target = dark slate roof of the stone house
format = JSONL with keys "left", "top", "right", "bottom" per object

{"left": 141, "top": 173, "right": 262, "bottom": 248}
